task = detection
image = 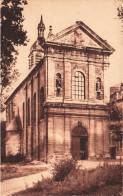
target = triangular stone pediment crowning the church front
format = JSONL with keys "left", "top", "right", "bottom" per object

{"left": 47, "top": 21, "right": 114, "bottom": 53}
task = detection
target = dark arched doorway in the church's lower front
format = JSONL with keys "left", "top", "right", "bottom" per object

{"left": 71, "top": 124, "right": 88, "bottom": 160}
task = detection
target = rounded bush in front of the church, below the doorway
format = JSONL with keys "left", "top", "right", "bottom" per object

{"left": 53, "top": 159, "right": 76, "bottom": 181}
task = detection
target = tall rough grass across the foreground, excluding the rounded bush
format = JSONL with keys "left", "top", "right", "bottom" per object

{"left": 17, "top": 165, "right": 122, "bottom": 195}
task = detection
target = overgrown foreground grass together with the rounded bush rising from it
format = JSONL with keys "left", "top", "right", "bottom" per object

{"left": 13, "top": 160, "right": 122, "bottom": 196}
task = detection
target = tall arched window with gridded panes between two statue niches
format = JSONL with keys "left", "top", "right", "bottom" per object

{"left": 73, "top": 71, "right": 85, "bottom": 100}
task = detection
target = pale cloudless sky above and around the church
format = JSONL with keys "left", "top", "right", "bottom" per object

{"left": 16, "top": 0, "right": 123, "bottom": 92}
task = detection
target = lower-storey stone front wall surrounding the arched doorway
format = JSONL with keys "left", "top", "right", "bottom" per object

{"left": 45, "top": 107, "right": 109, "bottom": 161}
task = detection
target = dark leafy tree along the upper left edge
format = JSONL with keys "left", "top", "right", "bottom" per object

{"left": 1, "top": 0, "right": 28, "bottom": 109}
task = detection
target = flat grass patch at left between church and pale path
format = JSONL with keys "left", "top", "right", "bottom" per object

{"left": 1, "top": 164, "right": 47, "bottom": 181}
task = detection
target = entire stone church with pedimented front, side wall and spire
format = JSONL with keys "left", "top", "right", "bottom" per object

{"left": 6, "top": 17, "right": 114, "bottom": 162}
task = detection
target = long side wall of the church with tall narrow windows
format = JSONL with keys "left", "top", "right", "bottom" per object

{"left": 6, "top": 61, "right": 46, "bottom": 160}
